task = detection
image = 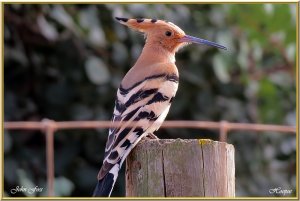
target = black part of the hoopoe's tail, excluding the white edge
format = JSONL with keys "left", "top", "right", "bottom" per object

{"left": 93, "top": 173, "right": 114, "bottom": 197}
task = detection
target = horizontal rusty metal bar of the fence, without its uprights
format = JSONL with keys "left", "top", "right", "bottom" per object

{"left": 4, "top": 121, "right": 296, "bottom": 133}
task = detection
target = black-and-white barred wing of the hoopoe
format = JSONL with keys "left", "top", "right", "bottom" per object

{"left": 98, "top": 74, "right": 178, "bottom": 180}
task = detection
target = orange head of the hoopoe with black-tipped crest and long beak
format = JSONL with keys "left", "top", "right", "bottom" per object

{"left": 116, "top": 17, "right": 226, "bottom": 53}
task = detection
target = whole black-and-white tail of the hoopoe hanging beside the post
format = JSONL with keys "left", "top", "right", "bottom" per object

{"left": 93, "top": 164, "right": 120, "bottom": 197}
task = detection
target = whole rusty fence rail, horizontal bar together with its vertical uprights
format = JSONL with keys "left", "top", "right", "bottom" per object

{"left": 4, "top": 119, "right": 296, "bottom": 196}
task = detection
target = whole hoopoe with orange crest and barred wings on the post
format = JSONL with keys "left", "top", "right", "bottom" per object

{"left": 93, "top": 17, "right": 226, "bottom": 197}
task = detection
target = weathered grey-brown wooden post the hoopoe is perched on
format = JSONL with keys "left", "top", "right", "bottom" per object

{"left": 126, "top": 139, "right": 235, "bottom": 197}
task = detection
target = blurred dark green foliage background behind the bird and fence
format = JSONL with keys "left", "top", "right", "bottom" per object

{"left": 4, "top": 4, "right": 297, "bottom": 197}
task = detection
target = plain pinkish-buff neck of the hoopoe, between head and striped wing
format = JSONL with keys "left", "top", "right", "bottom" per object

{"left": 134, "top": 43, "right": 175, "bottom": 67}
